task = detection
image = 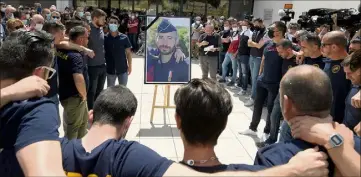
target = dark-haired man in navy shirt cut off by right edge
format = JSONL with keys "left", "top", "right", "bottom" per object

{"left": 342, "top": 50, "right": 361, "bottom": 132}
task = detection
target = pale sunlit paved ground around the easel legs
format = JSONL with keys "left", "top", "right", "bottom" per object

{"left": 59, "top": 58, "right": 265, "bottom": 164}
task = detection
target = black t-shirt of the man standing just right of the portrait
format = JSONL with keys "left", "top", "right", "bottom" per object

{"left": 198, "top": 33, "right": 221, "bottom": 56}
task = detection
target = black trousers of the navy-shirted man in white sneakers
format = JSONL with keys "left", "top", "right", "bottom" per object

{"left": 249, "top": 81, "right": 279, "bottom": 134}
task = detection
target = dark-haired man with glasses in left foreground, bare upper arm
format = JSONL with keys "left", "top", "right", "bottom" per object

{"left": 0, "top": 30, "right": 64, "bottom": 176}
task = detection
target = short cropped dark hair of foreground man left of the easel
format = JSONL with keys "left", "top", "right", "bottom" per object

{"left": 93, "top": 85, "right": 138, "bottom": 125}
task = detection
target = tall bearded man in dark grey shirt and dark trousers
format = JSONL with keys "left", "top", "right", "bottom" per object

{"left": 87, "top": 9, "right": 107, "bottom": 109}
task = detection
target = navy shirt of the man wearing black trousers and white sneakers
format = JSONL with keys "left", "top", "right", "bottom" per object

{"left": 259, "top": 41, "right": 283, "bottom": 84}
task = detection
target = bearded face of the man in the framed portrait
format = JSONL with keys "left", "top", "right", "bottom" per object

{"left": 156, "top": 31, "right": 177, "bottom": 55}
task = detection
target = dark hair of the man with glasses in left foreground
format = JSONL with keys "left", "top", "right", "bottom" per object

{"left": 0, "top": 30, "right": 54, "bottom": 80}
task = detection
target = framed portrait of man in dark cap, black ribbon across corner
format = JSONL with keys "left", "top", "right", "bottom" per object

{"left": 144, "top": 16, "right": 191, "bottom": 84}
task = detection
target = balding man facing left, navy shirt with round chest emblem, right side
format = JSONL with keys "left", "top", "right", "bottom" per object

{"left": 321, "top": 31, "right": 351, "bottom": 123}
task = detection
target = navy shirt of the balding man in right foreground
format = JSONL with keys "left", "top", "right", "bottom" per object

{"left": 254, "top": 136, "right": 361, "bottom": 177}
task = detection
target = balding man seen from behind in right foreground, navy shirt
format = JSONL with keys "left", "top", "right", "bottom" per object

{"left": 255, "top": 65, "right": 360, "bottom": 176}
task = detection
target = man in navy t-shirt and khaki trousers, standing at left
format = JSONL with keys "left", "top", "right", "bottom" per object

{"left": 58, "top": 26, "right": 89, "bottom": 139}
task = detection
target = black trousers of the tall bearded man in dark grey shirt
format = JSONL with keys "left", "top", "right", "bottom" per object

{"left": 87, "top": 65, "right": 107, "bottom": 110}
